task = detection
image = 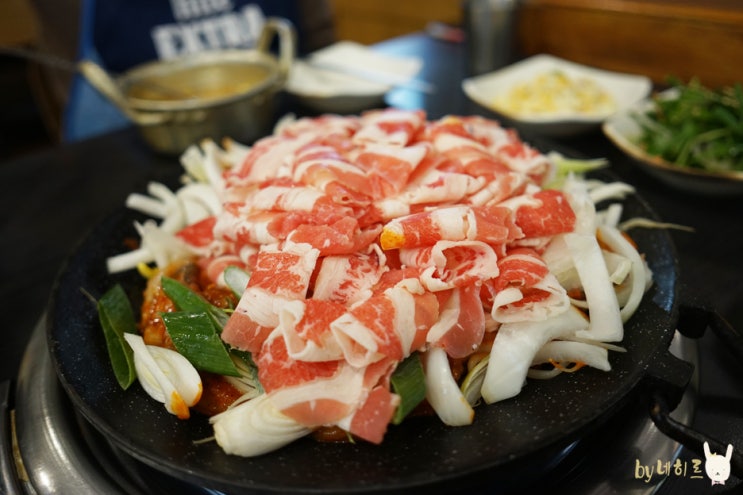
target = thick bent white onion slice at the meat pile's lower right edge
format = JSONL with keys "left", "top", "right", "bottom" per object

{"left": 480, "top": 308, "right": 588, "bottom": 404}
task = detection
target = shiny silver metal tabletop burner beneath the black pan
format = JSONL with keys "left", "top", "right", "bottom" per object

{"left": 3, "top": 318, "right": 698, "bottom": 495}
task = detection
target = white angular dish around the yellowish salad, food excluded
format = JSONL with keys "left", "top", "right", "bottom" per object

{"left": 462, "top": 54, "right": 652, "bottom": 137}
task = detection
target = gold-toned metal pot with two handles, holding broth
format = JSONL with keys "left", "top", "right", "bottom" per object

{"left": 79, "top": 18, "right": 296, "bottom": 154}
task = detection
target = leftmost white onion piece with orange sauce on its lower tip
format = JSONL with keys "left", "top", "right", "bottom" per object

{"left": 124, "top": 333, "right": 203, "bottom": 419}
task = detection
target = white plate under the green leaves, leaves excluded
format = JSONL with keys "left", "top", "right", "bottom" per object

{"left": 602, "top": 90, "right": 743, "bottom": 196}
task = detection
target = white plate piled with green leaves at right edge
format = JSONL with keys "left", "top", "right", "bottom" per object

{"left": 602, "top": 80, "right": 743, "bottom": 196}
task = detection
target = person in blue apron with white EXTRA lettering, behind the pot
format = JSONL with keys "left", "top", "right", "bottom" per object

{"left": 26, "top": 0, "right": 334, "bottom": 142}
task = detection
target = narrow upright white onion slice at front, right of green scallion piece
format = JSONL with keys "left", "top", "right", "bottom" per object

{"left": 422, "top": 347, "right": 475, "bottom": 426}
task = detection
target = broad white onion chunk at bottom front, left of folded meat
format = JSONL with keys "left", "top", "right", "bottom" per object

{"left": 209, "top": 394, "right": 312, "bottom": 457}
